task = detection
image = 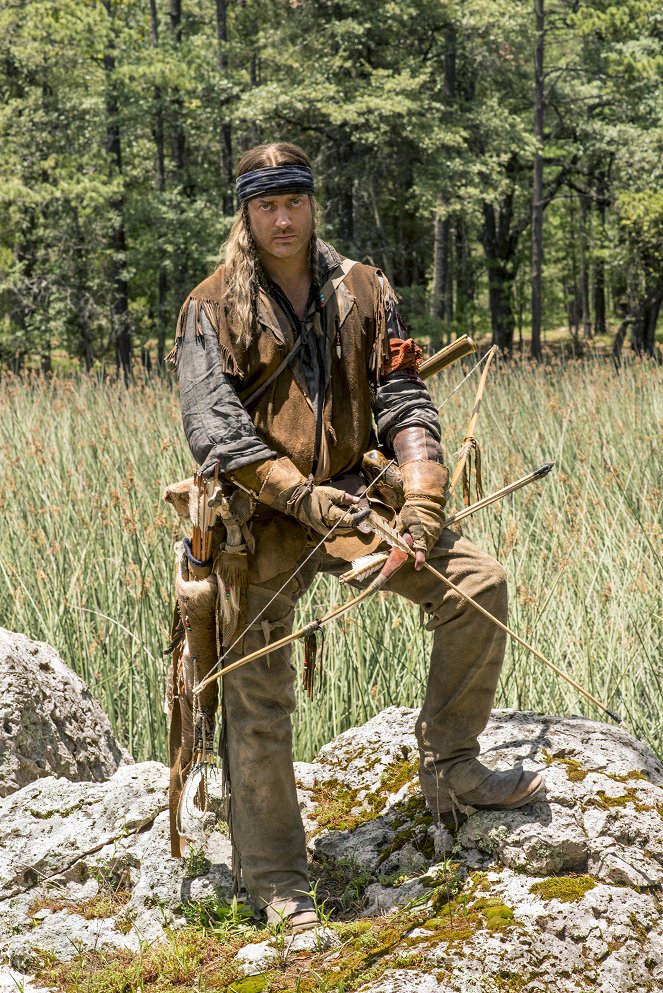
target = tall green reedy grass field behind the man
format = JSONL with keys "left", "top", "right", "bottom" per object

{"left": 0, "top": 361, "right": 663, "bottom": 759}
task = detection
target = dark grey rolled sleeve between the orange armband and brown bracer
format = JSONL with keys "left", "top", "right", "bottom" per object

{"left": 373, "top": 372, "right": 441, "bottom": 448}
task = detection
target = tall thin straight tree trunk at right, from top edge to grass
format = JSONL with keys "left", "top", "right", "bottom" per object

{"left": 530, "top": 0, "right": 544, "bottom": 361}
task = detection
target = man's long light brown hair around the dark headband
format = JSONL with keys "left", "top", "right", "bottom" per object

{"left": 223, "top": 141, "right": 319, "bottom": 346}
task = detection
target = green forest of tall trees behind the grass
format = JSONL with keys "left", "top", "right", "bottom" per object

{"left": 0, "top": 0, "right": 663, "bottom": 374}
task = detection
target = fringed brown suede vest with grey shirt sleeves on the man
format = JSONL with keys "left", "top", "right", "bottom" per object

{"left": 171, "top": 241, "right": 440, "bottom": 582}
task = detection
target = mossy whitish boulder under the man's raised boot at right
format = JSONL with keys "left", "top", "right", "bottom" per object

{"left": 298, "top": 708, "right": 663, "bottom": 993}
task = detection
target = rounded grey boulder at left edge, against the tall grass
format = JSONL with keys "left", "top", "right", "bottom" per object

{"left": 0, "top": 628, "right": 132, "bottom": 796}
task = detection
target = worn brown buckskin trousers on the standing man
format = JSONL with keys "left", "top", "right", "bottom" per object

{"left": 224, "top": 529, "right": 508, "bottom": 915}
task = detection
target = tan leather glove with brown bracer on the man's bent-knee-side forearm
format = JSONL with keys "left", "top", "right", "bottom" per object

{"left": 393, "top": 427, "right": 449, "bottom": 569}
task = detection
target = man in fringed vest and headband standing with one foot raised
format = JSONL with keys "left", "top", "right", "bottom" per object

{"left": 176, "top": 143, "right": 542, "bottom": 929}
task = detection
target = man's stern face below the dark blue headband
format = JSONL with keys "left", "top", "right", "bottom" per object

{"left": 248, "top": 193, "right": 313, "bottom": 259}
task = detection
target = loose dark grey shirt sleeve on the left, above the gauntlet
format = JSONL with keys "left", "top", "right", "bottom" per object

{"left": 177, "top": 307, "right": 276, "bottom": 473}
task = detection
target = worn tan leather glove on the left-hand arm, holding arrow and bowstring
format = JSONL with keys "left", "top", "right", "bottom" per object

{"left": 231, "top": 456, "right": 359, "bottom": 535}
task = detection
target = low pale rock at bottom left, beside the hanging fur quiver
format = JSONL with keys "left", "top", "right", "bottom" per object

{"left": 0, "top": 762, "right": 232, "bottom": 972}
